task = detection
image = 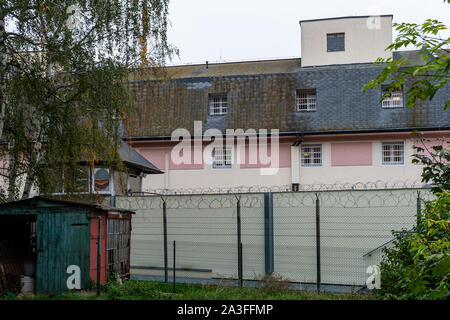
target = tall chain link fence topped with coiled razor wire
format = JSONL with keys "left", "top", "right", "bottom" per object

{"left": 116, "top": 188, "right": 433, "bottom": 287}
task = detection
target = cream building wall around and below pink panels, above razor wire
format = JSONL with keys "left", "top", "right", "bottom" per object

{"left": 143, "top": 139, "right": 428, "bottom": 191}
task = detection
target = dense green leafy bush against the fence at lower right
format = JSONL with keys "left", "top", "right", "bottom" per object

{"left": 380, "top": 192, "right": 450, "bottom": 299}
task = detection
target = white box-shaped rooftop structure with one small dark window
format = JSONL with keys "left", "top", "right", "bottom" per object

{"left": 300, "top": 15, "right": 393, "bottom": 67}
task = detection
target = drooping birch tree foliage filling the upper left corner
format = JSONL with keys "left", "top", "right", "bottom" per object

{"left": 0, "top": 0, "right": 177, "bottom": 199}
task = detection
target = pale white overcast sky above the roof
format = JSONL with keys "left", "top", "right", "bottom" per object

{"left": 168, "top": 0, "right": 450, "bottom": 64}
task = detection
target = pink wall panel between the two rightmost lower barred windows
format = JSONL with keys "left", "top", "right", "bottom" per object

{"left": 331, "top": 142, "right": 372, "bottom": 167}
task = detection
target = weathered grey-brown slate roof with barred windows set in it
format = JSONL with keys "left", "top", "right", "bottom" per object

{"left": 126, "top": 51, "right": 450, "bottom": 139}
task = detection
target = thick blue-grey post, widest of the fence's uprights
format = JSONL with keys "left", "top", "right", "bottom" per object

{"left": 264, "top": 192, "right": 275, "bottom": 275}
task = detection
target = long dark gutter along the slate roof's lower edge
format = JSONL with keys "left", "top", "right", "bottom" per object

{"left": 123, "top": 127, "right": 450, "bottom": 142}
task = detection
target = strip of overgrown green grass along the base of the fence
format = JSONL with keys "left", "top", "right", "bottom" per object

{"left": 4, "top": 280, "right": 375, "bottom": 300}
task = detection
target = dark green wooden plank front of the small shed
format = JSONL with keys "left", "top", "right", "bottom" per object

{"left": 36, "top": 207, "right": 90, "bottom": 295}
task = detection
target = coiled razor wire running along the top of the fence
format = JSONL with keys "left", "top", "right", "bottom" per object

{"left": 116, "top": 182, "right": 434, "bottom": 210}
